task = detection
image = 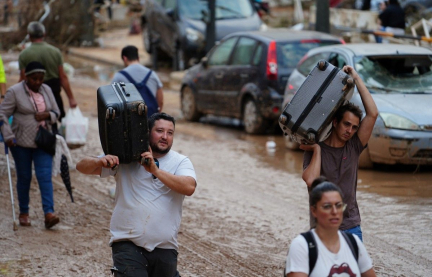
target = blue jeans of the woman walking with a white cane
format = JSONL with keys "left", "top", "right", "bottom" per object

{"left": 10, "top": 146, "right": 54, "bottom": 214}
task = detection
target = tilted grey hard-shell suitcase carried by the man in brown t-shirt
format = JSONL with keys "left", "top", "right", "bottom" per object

{"left": 279, "top": 60, "right": 354, "bottom": 144}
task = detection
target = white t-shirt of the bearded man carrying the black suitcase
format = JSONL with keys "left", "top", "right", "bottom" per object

{"left": 101, "top": 150, "right": 196, "bottom": 251}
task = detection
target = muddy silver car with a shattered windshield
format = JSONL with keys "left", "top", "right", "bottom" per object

{"left": 284, "top": 43, "right": 432, "bottom": 168}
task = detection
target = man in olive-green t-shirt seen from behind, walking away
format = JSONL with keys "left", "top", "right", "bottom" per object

{"left": 18, "top": 21, "right": 77, "bottom": 120}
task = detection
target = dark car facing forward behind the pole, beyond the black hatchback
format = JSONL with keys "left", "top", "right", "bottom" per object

{"left": 141, "top": 0, "right": 267, "bottom": 70}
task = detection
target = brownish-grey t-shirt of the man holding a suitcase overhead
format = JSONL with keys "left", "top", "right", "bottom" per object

{"left": 303, "top": 134, "right": 367, "bottom": 230}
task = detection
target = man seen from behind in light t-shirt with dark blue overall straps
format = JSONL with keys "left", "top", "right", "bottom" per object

{"left": 112, "top": 45, "right": 163, "bottom": 117}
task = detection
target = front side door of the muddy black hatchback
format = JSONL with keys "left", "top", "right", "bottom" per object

{"left": 196, "top": 37, "right": 238, "bottom": 114}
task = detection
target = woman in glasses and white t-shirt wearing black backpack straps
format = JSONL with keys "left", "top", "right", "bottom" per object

{"left": 284, "top": 179, "right": 376, "bottom": 277}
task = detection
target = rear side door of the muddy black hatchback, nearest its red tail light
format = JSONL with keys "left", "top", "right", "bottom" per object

{"left": 216, "top": 37, "right": 262, "bottom": 116}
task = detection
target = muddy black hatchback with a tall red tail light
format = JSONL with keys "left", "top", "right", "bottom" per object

{"left": 181, "top": 29, "right": 343, "bottom": 134}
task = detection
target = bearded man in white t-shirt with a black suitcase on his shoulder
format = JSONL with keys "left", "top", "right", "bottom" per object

{"left": 76, "top": 113, "right": 197, "bottom": 277}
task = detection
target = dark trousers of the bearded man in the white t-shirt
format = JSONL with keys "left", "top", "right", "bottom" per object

{"left": 111, "top": 241, "right": 180, "bottom": 277}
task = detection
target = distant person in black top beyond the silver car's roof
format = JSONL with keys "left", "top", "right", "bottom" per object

{"left": 378, "top": 0, "right": 405, "bottom": 43}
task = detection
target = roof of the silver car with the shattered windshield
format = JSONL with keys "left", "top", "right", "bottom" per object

{"left": 310, "top": 43, "right": 432, "bottom": 56}
